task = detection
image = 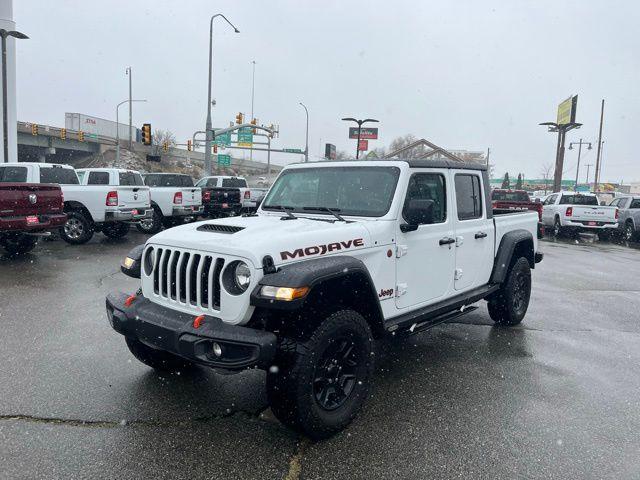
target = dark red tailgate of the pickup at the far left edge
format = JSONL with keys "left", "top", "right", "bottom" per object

{"left": 0, "top": 183, "right": 62, "bottom": 216}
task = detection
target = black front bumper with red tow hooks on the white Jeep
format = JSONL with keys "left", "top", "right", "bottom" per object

{"left": 106, "top": 293, "right": 277, "bottom": 371}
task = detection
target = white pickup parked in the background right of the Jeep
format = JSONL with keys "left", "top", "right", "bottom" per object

{"left": 542, "top": 192, "right": 618, "bottom": 237}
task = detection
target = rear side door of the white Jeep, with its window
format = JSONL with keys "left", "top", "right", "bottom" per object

{"left": 453, "top": 170, "right": 494, "bottom": 290}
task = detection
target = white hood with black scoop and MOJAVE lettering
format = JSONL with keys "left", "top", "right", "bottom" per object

{"left": 148, "top": 215, "right": 372, "bottom": 268}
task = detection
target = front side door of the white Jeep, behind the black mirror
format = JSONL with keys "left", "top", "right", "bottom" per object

{"left": 396, "top": 169, "right": 455, "bottom": 309}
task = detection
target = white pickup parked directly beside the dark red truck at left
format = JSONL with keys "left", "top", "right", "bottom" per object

{"left": 3, "top": 162, "right": 152, "bottom": 245}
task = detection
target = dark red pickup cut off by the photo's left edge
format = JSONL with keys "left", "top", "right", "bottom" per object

{"left": 0, "top": 180, "right": 67, "bottom": 255}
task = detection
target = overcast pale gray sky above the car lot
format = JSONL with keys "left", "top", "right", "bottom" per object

{"left": 14, "top": 0, "right": 640, "bottom": 181}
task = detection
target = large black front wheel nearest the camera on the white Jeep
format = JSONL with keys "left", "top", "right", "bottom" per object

{"left": 267, "top": 310, "right": 374, "bottom": 439}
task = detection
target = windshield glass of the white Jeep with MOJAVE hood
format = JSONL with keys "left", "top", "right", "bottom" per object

{"left": 262, "top": 167, "right": 400, "bottom": 217}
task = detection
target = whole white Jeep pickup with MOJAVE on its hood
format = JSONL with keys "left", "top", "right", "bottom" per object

{"left": 106, "top": 160, "right": 542, "bottom": 438}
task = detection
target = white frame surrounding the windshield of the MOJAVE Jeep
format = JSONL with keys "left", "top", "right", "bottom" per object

{"left": 260, "top": 164, "right": 402, "bottom": 218}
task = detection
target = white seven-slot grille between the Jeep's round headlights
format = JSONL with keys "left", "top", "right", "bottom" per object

{"left": 152, "top": 248, "right": 224, "bottom": 311}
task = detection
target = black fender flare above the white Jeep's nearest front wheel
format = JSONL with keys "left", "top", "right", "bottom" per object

{"left": 251, "top": 255, "right": 384, "bottom": 331}
